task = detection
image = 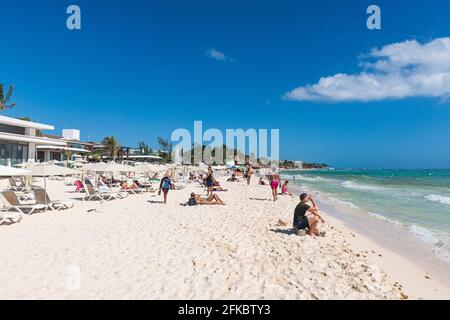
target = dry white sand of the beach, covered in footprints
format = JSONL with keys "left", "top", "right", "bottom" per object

{"left": 0, "top": 178, "right": 450, "bottom": 299}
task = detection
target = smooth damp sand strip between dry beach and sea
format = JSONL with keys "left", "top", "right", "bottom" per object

{"left": 290, "top": 185, "right": 450, "bottom": 299}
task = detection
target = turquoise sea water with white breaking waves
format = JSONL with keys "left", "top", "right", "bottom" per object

{"left": 282, "top": 169, "right": 450, "bottom": 262}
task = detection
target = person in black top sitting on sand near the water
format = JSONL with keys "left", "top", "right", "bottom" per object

{"left": 293, "top": 193, "right": 325, "bottom": 237}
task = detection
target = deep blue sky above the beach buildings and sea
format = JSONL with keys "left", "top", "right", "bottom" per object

{"left": 0, "top": 0, "right": 450, "bottom": 168}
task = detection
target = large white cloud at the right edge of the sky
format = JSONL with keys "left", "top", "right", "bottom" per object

{"left": 284, "top": 38, "right": 450, "bottom": 102}
